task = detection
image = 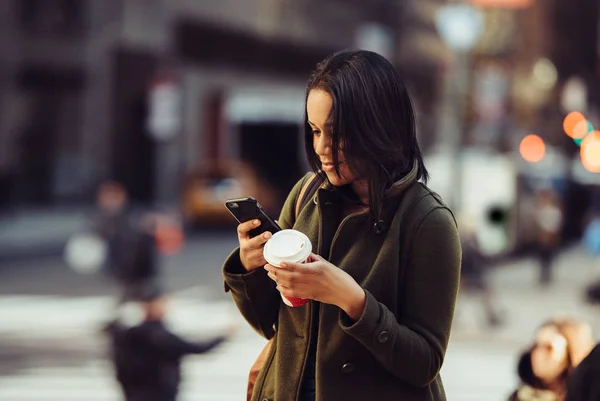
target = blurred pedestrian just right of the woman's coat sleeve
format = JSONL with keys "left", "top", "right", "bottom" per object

{"left": 459, "top": 214, "right": 502, "bottom": 327}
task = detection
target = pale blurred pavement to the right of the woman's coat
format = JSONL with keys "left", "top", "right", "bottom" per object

{"left": 442, "top": 247, "right": 600, "bottom": 401}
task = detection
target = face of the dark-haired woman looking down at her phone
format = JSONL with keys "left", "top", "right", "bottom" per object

{"left": 306, "top": 89, "right": 356, "bottom": 186}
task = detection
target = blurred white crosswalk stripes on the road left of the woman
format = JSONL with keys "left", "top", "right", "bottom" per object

{"left": 0, "top": 291, "right": 266, "bottom": 401}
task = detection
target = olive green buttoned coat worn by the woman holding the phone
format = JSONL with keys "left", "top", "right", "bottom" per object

{"left": 223, "top": 167, "right": 461, "bottom": 401}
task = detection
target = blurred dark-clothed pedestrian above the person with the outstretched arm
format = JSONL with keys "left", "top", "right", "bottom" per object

{"left": 93, "top": 181, "right": 161, "bottom": 304}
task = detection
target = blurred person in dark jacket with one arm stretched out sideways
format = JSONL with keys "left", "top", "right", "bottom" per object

{"left": 106, "top": 294, "right": 232, "bottom": 401}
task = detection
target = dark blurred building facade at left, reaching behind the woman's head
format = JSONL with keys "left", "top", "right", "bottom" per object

{"left": 0, "top": 0, "right": 448, "bottom": 212}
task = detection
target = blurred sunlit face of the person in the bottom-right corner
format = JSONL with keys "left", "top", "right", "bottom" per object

{"left": 531, "top": 326, "right": 569, "bottom": 383}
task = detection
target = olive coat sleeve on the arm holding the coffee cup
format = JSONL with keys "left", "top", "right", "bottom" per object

{"left": 340, "top": 207, "right": 461, "bottom": 387}
